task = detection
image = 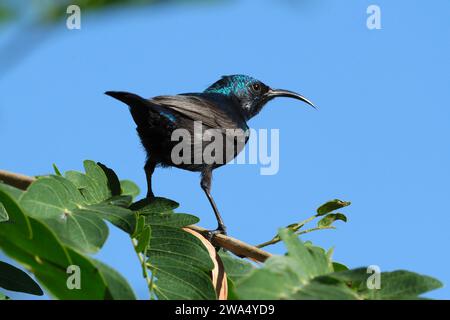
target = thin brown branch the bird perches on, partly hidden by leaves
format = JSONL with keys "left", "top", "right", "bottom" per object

{"left": 0, "top": 170, "right": 271, "bottom": 262}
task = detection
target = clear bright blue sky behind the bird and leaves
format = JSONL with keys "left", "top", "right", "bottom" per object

{"left": 0, "top": 0, "right": 450, "bottom": 299}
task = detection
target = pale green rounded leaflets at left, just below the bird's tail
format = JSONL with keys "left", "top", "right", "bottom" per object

{"left": 20, "top": 165, "right": 136, "bottom": 253}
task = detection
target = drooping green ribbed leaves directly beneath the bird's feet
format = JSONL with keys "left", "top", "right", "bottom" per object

{"left": 130, "top": 198, "right": 216, "bottom": 300}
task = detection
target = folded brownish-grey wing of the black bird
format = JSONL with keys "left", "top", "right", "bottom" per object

{"left": 149, "top": 95, "right": 240, "bottom": 129}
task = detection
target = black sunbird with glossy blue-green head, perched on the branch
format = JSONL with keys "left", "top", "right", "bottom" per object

{"left": 105, "top": 75, "right": 314, "bottom": 236}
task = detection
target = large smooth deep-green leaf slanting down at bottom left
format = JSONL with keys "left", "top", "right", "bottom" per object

{"left": 0, "top": 190, "right": 134, "bottom": 299}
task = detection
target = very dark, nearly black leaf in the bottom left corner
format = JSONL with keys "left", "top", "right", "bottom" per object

{"left": 0, "top": 261, "right": 44, "bottom": 296}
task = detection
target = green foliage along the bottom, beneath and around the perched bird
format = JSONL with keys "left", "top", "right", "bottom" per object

{"left": 0, "top": 160, "right": 442, "bottom": 300}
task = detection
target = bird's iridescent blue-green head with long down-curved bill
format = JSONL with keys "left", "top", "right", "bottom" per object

{"left": 205, "top": 75, "right": 315, "bottom": 119}
